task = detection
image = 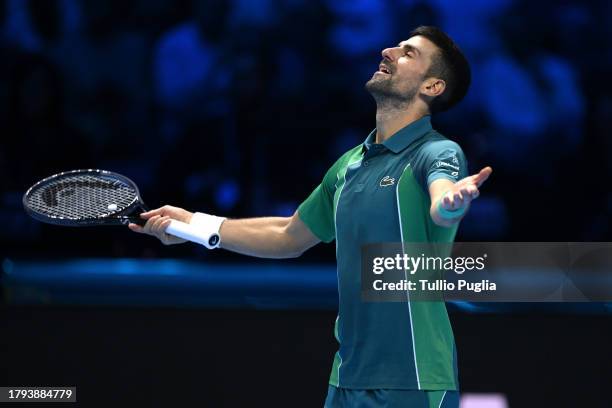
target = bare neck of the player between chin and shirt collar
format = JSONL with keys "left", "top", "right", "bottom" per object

{"left": 376, "top": 102, "right": 428, "bottom": 143}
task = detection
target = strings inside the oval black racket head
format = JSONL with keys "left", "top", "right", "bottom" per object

{"left": 28, "top": 174, "right": 137, "bottom": 220}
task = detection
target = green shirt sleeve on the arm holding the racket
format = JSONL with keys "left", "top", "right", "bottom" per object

{"left": 298, "top": 156, "right": 344, "bottom": 242}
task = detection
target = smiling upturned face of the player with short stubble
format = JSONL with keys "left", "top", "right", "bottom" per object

{"left": 366, "top": 35, "right": 437, "bottom": 102}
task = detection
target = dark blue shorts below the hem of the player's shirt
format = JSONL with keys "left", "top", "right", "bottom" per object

{"left": 324, "top": 385, "right": 459, "bottom": 408}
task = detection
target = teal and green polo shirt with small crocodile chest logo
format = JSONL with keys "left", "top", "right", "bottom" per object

{"left": 298, "top": 116, "right": 467, "bottom": 390}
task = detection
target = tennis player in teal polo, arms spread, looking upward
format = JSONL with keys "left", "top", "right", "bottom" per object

{"left": 129, "top": 26, "right": 492, "bottom": 408}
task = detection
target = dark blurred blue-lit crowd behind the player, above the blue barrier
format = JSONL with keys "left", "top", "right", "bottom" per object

{"left": 0, "top": 0, "right": 612, "bottom": 255}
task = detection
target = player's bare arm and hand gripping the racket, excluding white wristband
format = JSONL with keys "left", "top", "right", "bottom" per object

{"left": 129, "top": 206, "right": 320, "bottom": 258}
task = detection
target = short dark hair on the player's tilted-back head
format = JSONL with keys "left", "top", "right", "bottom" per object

{"left": 409, "top": 26, "right": 472, "bottom": 113}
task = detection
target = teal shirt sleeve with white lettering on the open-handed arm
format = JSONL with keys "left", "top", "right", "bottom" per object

{"left": 421, "top": 139, "right": 468, "bottom": 191}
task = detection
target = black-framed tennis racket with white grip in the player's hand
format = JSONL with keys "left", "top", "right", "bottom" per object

{"left": 23, "top": 169, "right": 220, "bottom": 249}
